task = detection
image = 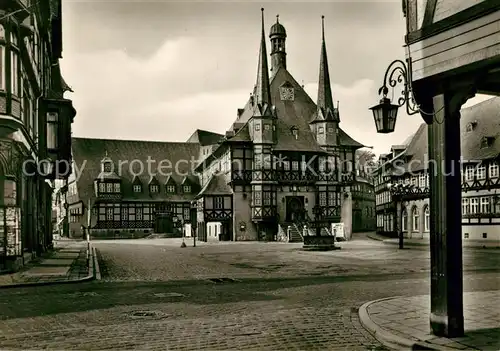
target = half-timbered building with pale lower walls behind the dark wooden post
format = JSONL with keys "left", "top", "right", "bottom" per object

{"left": 375, "top": 98, "right": 500, "bottom": 241}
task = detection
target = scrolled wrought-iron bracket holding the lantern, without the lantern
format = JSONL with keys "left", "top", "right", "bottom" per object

{"left": 378, "top": 60, "right": 420, "bottom": 115}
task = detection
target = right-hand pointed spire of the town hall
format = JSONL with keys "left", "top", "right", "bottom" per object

{"left": 317, "top": 16, "right": 336, "bottom": 120}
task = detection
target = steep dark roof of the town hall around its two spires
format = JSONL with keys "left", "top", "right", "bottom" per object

{"left": 229, "top": 67, "right": 363, "bottom": 152}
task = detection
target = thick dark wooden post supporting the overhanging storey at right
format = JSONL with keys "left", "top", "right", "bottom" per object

{"left": 425, "top": 82, "right": 473, "bottom": 338}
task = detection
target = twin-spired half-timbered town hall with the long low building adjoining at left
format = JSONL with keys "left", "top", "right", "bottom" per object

{"left": 68, "top": 13, "right": 374, "bottom": 241}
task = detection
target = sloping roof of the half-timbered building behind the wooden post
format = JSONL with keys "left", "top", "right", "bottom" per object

{"left": 384, "top": 97, "right": 500, "bottom": 172}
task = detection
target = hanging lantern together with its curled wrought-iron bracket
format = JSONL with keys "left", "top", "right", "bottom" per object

{"left": 370, "top": 60, "right": 420, "bottom": 134}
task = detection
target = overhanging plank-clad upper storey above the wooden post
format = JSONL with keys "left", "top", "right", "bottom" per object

{"left": 403, "top": 0, "right": 500, "bottom": 90}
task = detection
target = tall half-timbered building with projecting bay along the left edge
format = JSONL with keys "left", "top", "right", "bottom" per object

{"left": 0, "top": 0, "right": 75, "bottom": 270}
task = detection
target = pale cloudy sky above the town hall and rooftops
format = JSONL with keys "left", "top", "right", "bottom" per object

{"left": 61, "top": 0, "right": 490, "bottom": 153}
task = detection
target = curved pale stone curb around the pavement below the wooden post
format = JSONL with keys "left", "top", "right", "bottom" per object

{"left": 358, "top": 296, "right": 456, "bottom": 351}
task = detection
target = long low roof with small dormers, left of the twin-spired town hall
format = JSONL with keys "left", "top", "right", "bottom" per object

{"left": 72, "top": 138, "right": 200, "bottom": 209}
